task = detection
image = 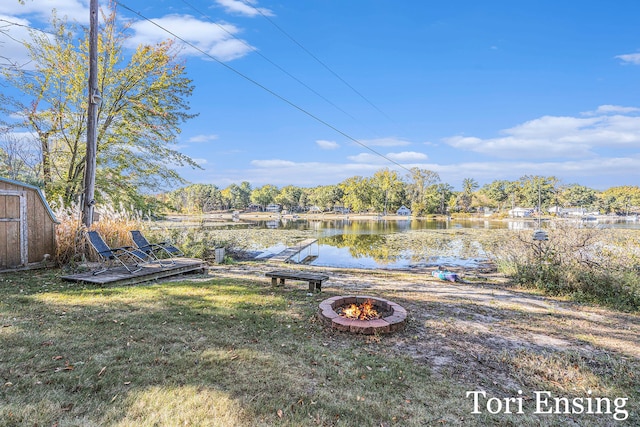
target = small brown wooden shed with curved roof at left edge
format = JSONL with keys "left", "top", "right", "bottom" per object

{"left": 0, "top": 177, "right": 58, "bottom": 270}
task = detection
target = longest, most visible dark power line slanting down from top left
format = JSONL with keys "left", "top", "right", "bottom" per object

{"left": 115, "top": 0, "right": 411, "bottom": 172}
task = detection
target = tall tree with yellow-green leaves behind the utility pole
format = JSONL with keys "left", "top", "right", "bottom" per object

{"left": 0, "top": 2, "right": 197, "bottom": 211}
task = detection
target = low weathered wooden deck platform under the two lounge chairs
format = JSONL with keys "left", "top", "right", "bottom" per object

{"left": 61, "top": 258, "right": 207, "bottom": 285}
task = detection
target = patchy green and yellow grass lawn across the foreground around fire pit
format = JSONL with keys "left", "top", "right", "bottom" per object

{"left": 0, "top": 271, "right": 640, "bottom": 427}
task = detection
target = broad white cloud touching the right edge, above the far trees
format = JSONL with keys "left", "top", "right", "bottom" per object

{"left": 444, "top": 106, "right": 640, "bottom": 159}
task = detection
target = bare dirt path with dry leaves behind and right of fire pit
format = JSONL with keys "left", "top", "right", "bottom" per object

{"left": 202, "top": 264, "right": 640, "bottom": 402}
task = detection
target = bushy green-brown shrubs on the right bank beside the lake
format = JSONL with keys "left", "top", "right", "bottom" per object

{"left": 493, "top": 221, "right": 640, "bottom": 311}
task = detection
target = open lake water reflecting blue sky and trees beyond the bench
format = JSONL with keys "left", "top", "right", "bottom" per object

{"left": 244, "top": 219, "right": 640, "bottom": 269}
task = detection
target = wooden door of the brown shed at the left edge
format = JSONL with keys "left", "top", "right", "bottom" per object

{"left": 0, "top": 190, "right": 29, "bottom": 269}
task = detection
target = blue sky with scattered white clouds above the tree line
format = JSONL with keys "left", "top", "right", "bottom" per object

{"left": 0, "top": 0, "right": 640, "bottom": 189}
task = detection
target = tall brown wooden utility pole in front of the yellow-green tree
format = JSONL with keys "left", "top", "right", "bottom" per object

{"left": 82, "top": 0, "right": 102, "bottom": 227}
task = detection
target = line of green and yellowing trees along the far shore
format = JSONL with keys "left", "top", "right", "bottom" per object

{"left": 158, "top": 168, "right": 640, "bottom": 216}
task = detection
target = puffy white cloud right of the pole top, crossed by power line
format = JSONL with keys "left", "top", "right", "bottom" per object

{"left": 127, "top": 15, "right": 253, "bottom": 61}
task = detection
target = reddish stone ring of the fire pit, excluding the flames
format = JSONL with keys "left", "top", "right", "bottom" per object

{"left": 318, "top": 295, "right": 407, "bottom": 335}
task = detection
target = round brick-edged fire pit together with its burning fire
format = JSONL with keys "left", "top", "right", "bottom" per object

{"left": 318, "top": 296, "right": 407, "bottom": 334}
